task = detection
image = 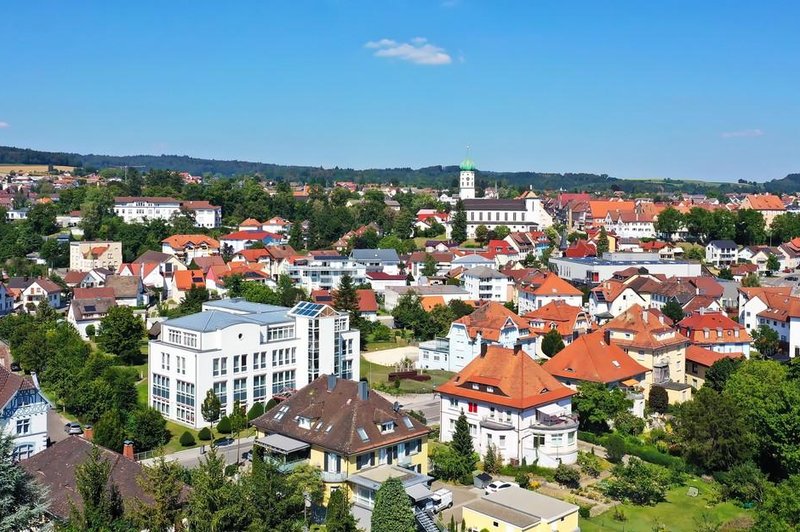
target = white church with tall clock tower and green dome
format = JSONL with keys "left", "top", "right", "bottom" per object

{"left": 459, "top": 158, "right": 553, "bottom": 238}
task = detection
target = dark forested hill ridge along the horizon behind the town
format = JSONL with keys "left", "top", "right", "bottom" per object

{"left": 0, "top": 146, "right": 784, "bottom": 194}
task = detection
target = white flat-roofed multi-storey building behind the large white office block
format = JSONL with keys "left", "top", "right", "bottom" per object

{"left": 286, "top": 252, "right": 367, "bottom": 292}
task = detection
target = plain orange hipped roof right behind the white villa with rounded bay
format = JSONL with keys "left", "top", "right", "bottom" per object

{"left": 542, "top": 331, "right": 649, "bottom": 384}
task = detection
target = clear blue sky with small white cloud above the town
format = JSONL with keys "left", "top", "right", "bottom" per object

{"left": 0, "top": 0, "right": 800, "bottom": 180}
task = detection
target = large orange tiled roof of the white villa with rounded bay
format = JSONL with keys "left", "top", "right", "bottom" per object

{"left": 436, "top": 345, "right": 576, "bottom": 409}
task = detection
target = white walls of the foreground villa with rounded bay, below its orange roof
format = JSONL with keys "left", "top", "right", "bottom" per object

{"left": 440, "top": 394, "right": 578, "bottom": 467}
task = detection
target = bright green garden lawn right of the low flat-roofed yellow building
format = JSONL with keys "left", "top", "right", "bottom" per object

{"left": 580, "top": 478, "right": 752, "bottom": 532}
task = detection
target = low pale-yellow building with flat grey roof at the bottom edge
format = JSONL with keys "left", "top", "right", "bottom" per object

{"left": 461, "top": 487, "right": 580, "bottom": 532}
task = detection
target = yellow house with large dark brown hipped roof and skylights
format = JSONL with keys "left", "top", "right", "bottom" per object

{"left": 252, "top": 375, "right": 432, "bottom": 504}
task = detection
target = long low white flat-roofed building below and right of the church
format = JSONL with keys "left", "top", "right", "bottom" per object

{"left": 550, "top": 252, "right": 702, "bottom": 285}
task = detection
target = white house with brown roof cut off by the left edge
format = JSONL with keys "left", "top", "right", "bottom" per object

{"left": 0, "top": 364, "right": 50, "bottom": 462}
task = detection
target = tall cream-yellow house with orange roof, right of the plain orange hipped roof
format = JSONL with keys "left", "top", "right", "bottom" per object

{"left": 600, "top": 305, "right": 691, "bottom": 403}
